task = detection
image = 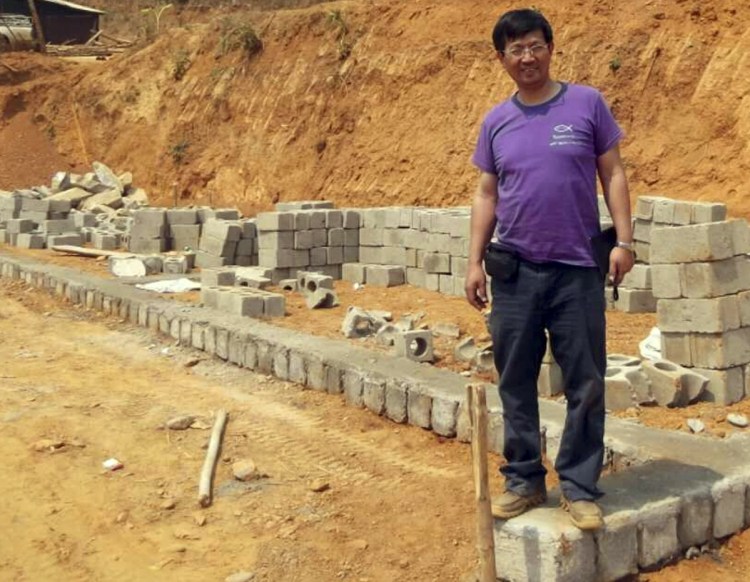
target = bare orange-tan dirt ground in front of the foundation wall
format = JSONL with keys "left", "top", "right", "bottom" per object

{"left": 0, "top": 266, "right": 750, "bottom": 582}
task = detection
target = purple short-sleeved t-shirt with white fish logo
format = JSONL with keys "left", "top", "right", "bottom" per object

{"left": 472, "top": 83, "right": 622, "bottom": 267}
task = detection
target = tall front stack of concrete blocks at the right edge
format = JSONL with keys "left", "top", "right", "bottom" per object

{"left": 651, "top": 220, "right": 750, "bottom": 404}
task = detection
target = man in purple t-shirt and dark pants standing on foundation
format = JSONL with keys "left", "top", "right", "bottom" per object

{"left": 466, "top": 10, "right": 634, "bottom": 529}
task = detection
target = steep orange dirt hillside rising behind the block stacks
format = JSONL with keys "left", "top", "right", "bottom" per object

{"left": 0, "top": 0, "right": 750, "bottom": 216}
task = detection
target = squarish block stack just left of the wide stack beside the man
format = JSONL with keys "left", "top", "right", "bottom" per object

{"left": 255, "top": 203, "right": 360, "bottom": 283}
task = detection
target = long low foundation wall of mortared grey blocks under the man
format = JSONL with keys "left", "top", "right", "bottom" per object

{"left": 0, "top": 253, "right": 750, "bottom": 582}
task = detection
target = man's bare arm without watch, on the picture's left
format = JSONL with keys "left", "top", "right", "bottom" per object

{"left": 465, "top": 172, "right": 497, "bottom": 310}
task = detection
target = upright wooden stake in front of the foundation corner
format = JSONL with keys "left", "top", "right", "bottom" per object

{"left": 466, "top": 384, "right": 497, "bottom": 582}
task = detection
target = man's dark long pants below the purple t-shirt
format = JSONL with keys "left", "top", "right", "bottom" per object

{"left": 490, "top": 260, "right": 606, "bottom": 501}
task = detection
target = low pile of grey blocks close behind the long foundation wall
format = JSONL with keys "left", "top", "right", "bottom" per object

{"left": 201, "top": 267, "right": 286, "bottom": 317}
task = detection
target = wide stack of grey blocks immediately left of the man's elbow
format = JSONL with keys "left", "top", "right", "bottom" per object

{"left": 345, "top": 207, "right": 469, "bottom": 296}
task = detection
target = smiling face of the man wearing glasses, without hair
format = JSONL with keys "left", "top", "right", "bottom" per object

{"left": 497, "top": 30, "right": 554, "bottom": 89}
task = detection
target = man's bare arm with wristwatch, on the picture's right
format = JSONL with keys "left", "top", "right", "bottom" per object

{"left": 596, "top": 145, "right": 635, "bottom": 285}
